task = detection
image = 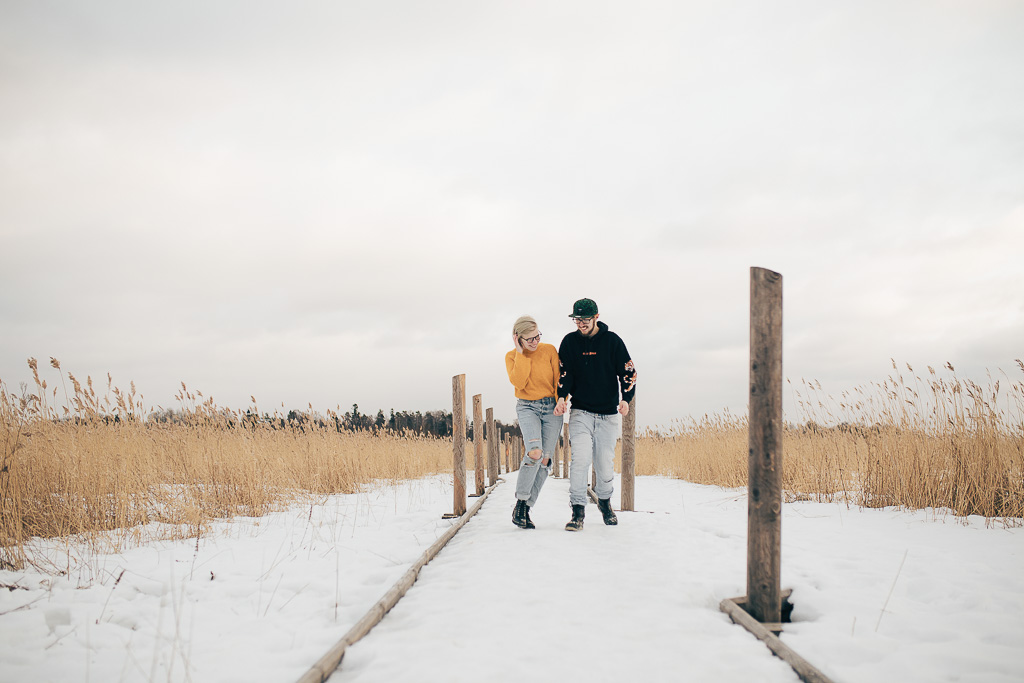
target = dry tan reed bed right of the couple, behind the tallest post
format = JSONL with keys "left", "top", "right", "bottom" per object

{"left": 637, "top": 360, "right": 1024, "bottom": 525}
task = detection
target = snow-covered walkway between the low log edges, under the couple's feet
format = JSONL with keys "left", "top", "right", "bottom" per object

{"left": 330, "top": 473, "right": 798, "bottom": 683}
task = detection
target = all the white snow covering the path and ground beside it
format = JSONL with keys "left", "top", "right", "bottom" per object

{"left": 0, "top": 473, "right": 1024, "bottom": 683}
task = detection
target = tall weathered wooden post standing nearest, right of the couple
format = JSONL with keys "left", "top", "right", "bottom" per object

{"left": 746, "top": 267, "right": 782, "bottom": 624}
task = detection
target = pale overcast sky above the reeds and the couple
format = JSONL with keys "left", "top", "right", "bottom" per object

{"left": 0, "top": 0, "right": 1024, "bottom": 426}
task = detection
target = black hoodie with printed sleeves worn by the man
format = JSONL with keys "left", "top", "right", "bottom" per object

{"left": 558, "top": 321, "right": 637, "bottom": 415}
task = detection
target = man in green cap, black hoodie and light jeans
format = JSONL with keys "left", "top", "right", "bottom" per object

{"left": 555, "top": 299, "right": 637, "bottom": 531}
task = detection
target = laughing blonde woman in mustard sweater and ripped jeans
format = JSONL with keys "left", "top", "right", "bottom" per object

{"left": 505, "top": 315, "right": 562, "bottom": 528}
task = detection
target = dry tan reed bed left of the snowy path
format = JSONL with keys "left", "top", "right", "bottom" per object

{"left": 0, "top": 359, "right": 452, "bottom": 567}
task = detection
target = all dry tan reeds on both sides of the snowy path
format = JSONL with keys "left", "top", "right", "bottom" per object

{"left": 0, "top": 358, "right": 1024, "bottom": 567}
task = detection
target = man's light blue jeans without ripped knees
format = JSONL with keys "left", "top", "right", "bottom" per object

{"left": 569, "top": 409, "right": 623, "bottom": 505}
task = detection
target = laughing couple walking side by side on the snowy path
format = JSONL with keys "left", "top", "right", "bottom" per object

{"left": 505, "top": 299, "right": 637, "bottom": 531}
